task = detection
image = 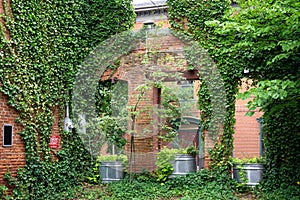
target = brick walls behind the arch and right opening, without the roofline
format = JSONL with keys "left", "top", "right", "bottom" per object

{"left": 102, "top": 29, "right": 262, "bottom": 171}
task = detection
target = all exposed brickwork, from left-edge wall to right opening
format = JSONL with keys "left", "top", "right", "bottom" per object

{"left": 0, "top": 0, "right": 262, "bottom": 185}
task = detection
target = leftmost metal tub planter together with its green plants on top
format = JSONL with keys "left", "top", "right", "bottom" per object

{"left": 97, "top": 154, "right": 128, "bottom": 183}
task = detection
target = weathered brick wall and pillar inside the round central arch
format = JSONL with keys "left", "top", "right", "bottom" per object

{"left": 102, "top": 32, "right": 190, "bottom": 171}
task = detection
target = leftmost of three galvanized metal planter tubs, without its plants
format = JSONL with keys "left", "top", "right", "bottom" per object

{"left": 99, "top": 161, "right": 124, "bottom": 183}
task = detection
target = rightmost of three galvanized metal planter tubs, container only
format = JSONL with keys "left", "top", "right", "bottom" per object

{"left": 233, "top": 164, "right": 264, "bottom": 186}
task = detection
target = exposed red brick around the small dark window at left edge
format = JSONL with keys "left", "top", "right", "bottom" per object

{"left": 0, "top": 0, "right": 60, "bottom": 185}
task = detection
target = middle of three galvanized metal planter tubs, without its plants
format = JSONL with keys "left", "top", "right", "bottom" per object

{"left": 169, "top": 154, "right": 197, "bottom": 178}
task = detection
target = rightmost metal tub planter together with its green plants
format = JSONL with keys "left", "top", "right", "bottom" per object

{"left": 232, "top": 157, "right": 264, "bottom": 186}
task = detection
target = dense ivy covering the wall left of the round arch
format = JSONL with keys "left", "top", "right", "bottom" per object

{"left": 0, "top": 0, "right": 134, "bottom": 198}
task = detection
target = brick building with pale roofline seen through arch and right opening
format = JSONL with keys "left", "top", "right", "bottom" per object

{"left": 96, "top": 0, "right": 263, "bottom": 171}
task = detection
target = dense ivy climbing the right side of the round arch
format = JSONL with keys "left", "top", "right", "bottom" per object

{"left": 167, "top": 0, "right": 236, "bottom": 170}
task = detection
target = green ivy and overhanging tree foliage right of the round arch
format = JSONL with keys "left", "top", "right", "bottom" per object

{"left": 168, "top": 0, "right": 300, "bottom": 194}
